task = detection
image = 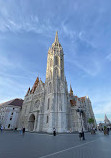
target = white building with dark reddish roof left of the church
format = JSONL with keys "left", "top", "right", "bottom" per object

{"left": 0, "top": 98, "right": 23, "bottom": 129}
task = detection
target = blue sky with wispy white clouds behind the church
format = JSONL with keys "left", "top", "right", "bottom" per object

{"left": 0, "top": 0, "right": 111, "bottom": 121}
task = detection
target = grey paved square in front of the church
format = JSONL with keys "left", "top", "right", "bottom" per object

{"left": 0, "top": 131, "right": 111, "bottom": 158}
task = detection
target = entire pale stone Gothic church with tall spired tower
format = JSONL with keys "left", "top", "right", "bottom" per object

{"left": 19, "top": 32, "right": 96, "bottom": 133}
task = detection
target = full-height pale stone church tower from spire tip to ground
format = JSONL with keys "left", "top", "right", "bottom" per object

{"left": 44, "top": 32, "right": 68, "bottom": 132}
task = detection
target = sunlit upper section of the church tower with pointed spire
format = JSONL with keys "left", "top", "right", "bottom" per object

{"left": 46, "top": 32, "right": 64, "bottom": 81}
